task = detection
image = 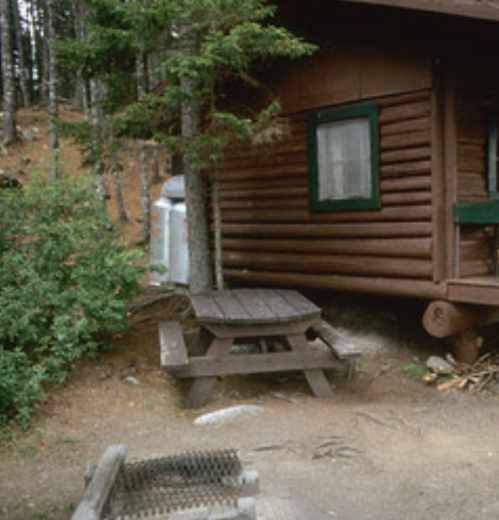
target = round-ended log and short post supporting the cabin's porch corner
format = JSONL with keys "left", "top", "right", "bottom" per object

{"left": 423, "top": 300, "right": 499, "bottom": 364}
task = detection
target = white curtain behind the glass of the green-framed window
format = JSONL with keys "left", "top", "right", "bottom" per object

{"left": 317, "top": 118, "right": 371, "bottom": 200}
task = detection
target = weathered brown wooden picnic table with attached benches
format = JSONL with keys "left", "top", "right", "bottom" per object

{"left": 160, "top": 289, "right": 359, "bottom": 408}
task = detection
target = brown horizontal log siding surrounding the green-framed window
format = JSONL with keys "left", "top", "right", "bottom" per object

{"left": 220, "top": 91, "right": 433, "bottom": 290}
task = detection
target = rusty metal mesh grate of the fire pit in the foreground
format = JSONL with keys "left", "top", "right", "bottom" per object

{"left": 104, "top": 450, "right": 243, "bottom": 520}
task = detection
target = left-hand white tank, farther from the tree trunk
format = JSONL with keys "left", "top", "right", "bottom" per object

{"left": 149, "top": 197, "right": 173, "bottom": 285}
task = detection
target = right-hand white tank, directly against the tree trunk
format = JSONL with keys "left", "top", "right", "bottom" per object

{"left": 169, "top": 202, "right": 189, "bottom": 285}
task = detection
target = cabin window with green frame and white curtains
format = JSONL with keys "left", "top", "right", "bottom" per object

{"left": 308, "top": 103, "right": 379, "bottom": 211}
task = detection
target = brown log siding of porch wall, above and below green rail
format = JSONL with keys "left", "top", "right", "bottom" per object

{"left": 456, "top": 88, "right": 499, "bottom": 278}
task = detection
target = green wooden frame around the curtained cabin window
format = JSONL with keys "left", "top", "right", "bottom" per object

{"left": 307, "top": 103, "right": 380, "bottom": 211}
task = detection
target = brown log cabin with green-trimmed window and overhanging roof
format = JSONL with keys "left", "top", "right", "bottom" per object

{"left": 214, "top": 0, "right": 499, "bottom": 362}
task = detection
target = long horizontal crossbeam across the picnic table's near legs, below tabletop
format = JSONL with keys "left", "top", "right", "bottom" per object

{"left": 175, "top": 347, "right": 344, "bottom": 378}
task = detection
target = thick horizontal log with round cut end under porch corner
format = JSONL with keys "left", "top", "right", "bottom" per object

{"left": 423, "top": 300, "right": 499, "bottom": 338}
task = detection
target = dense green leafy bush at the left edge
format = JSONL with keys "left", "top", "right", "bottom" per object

{"left": 0, "top": 177, "right": 146, "bottom": 423}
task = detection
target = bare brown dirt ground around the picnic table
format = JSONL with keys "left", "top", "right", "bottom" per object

{"left": 0, "top": 299, "right": 499, "bottom": 520}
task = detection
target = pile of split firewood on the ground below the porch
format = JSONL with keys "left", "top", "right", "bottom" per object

{"left": 423, "top": 353, "right": 499, "bottom": 393}
